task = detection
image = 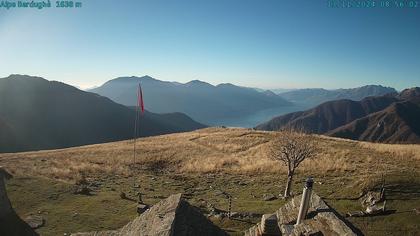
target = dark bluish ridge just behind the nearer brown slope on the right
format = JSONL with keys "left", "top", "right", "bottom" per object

{"left": 256, "top": 95, "right": 398, "bottom": 134}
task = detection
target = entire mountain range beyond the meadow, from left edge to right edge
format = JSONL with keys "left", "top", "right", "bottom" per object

{"left": 0, "top": 75, "right": 414, "bottom": 149}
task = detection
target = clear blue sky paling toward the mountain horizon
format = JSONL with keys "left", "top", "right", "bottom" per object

{"left": 0, "top": 0, "right": 420, "bottom": 89}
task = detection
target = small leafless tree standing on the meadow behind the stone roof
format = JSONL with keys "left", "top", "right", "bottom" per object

{"left": 270, "top": 130, "right": 315, "bottom": 198}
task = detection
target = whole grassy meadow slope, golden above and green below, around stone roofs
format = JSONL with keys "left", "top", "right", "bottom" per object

{"left": 0, "top": 128, "right": 420, "bottom": 235}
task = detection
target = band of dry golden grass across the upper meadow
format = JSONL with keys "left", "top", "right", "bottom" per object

{"left": 0, "top": 128, "right": 419, "bottom": 181}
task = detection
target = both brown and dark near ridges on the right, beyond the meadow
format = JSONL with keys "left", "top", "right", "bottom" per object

{"left": 256, "top": 87, "right": 420, "bottom": 143}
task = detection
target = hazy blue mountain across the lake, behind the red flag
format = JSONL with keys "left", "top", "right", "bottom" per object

{"left": 90, "top": 76, "right": 290, "bottom": 125}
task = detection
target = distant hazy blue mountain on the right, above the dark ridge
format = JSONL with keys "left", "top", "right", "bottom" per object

{"left": 279, "top": 85, "right": 397, "bottom": 106}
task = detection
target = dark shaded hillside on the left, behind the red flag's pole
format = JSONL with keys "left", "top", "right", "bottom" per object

{"left": 0, "top": 75, "right": 204, "bottom": 152}
